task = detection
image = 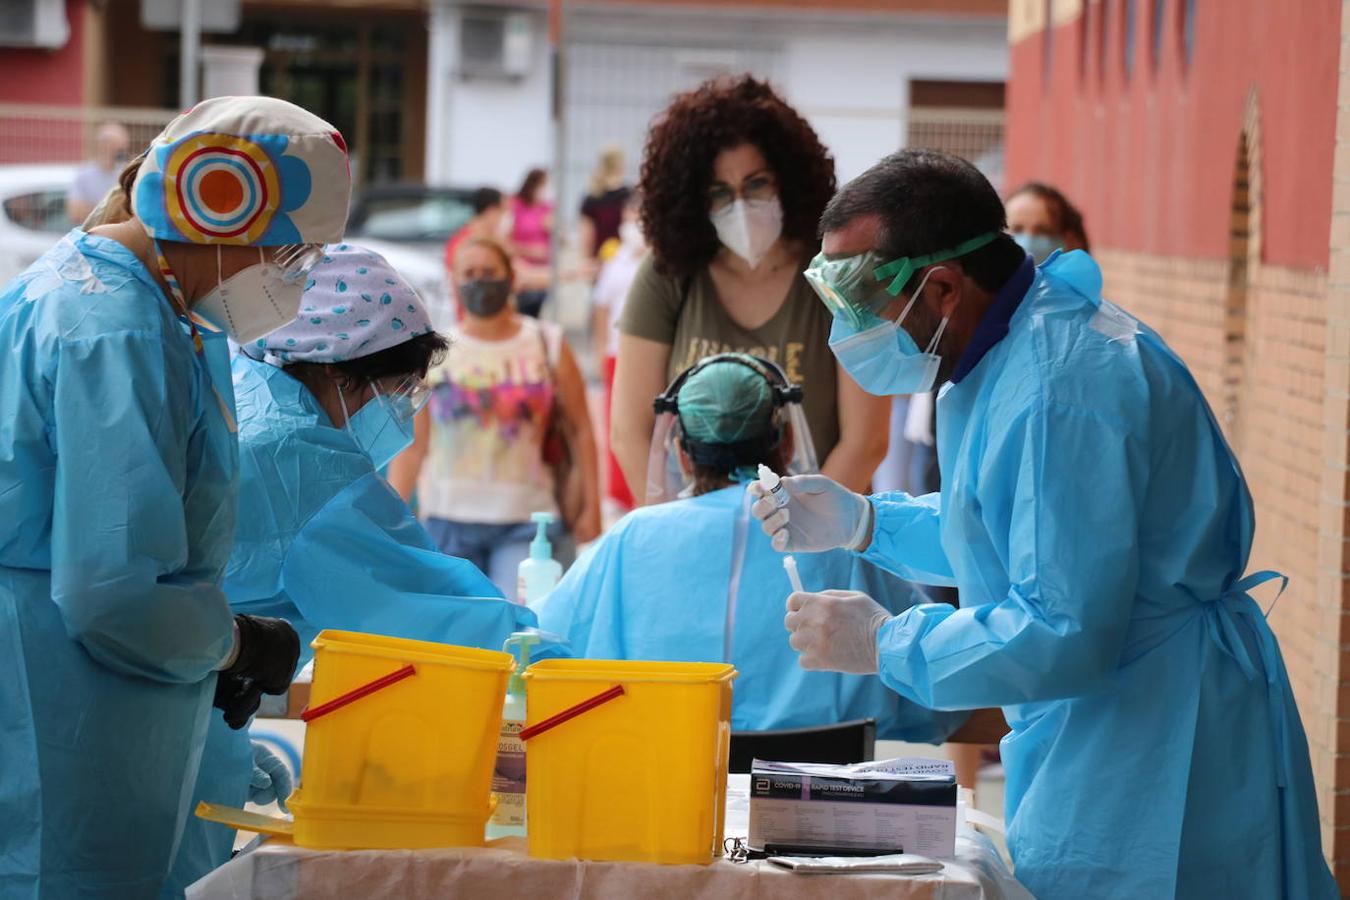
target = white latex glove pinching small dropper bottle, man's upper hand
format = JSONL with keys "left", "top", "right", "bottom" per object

{"left": 749, "top": 475, "right": 872, "bottom": 553}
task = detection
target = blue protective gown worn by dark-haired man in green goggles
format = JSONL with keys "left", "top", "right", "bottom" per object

{"left": 864, "top": 252, "right": 1337, "bottom": 900}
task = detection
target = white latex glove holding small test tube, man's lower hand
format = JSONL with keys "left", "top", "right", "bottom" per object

{"left": 783, "top": 591, "right": 891, "bottom": 675}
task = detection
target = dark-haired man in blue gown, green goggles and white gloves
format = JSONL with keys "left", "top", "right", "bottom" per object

{"left": 755, "top": 150, "right": 1337, "bottom": 900}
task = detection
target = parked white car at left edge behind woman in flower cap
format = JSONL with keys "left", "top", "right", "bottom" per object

{"left": 0, "top": 165, "right": 76, "bottom": 285}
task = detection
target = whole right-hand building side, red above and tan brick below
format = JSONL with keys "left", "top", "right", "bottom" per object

{"left": 1007, "top": 0, "right": 1350, "bottom": 892}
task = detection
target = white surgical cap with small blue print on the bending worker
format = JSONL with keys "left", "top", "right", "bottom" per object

{"left": 243, "top": 244, "right": 432, "bottom": 366}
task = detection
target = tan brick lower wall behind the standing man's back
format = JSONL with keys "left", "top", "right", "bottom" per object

{"left": 1098, "top": 249, "right": 1350, "bottom": 891}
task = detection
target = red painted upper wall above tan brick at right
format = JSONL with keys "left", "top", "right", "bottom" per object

{"left": 1007, "top": 0, "right": 1341, "bottom": 269}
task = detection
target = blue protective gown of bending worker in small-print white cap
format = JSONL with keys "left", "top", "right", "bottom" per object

{"left": 166, "top": 355, "right": 547, "bottom": 896}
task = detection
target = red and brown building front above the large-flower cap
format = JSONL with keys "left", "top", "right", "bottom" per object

{"left": 0, "top": 0, "right": 427, "bottom": 184}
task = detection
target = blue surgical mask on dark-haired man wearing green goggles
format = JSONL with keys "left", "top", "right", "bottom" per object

{"left": 830, "top": 266, "right": 949, "bottom": 397}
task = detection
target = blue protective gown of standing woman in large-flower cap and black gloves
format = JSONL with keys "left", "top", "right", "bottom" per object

{"left": 0, "top": 231, "right": 238, "bottom": 899}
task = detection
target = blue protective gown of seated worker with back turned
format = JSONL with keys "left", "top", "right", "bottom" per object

{"left": 535, "top": 486, "right": 965, "bottom": 743}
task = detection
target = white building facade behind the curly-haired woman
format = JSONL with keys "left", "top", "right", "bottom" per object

{"left": 427, "top": 0, "right": 1007, "bottom": 214}
